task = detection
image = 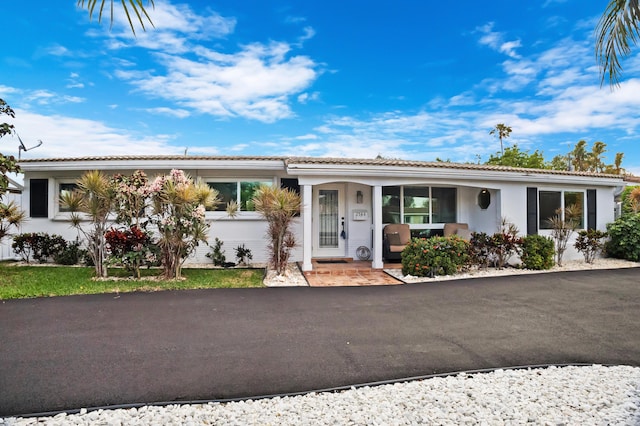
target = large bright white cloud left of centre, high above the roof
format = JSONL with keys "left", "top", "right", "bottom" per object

{"left": 116, "top": 42, "right": 318, "bottom": 123}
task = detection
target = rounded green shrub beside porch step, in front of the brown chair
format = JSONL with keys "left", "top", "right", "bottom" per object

{"left": 402, "top": 236, "right": 469, "bottom": 277}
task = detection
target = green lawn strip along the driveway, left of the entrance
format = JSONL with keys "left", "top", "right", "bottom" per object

{"left": 0, "top": 263, "right": 264, "bottom": 300}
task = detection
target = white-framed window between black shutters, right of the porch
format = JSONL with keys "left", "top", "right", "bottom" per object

{"left": 538, "top": 190, "right": 585, "bottom": 229}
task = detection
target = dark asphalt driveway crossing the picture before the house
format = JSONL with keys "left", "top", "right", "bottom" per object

{"left": 0, "top": 268, "right": 640, "bottom": 416}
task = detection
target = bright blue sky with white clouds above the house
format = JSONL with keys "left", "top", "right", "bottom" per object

{"left": 0, "top": 0, "right": 640, "bottom": 174}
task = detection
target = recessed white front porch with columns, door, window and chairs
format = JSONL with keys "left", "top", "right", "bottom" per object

{"left": 300, "top": 178, "right": 501, "bottom": 275}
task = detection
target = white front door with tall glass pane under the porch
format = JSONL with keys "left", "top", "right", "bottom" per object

{"left": 313, "top": 185, "right": 347, "bottom": 257}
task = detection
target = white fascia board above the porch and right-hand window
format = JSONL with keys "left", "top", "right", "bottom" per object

{"left": 288, "top": 164, "right": 623, "bottom": 186}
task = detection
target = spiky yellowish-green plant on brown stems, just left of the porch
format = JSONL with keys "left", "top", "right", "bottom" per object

{"left": 253, "top": 186, "right": 302, "bottom": 275}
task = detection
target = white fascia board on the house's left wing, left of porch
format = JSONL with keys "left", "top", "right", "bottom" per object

{"left": 20, "top": 158, "right": 284, "bottom": 172}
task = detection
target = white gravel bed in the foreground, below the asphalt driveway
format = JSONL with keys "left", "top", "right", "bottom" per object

{"left": 0, "top": 365, "right": 640, "bottom": 425}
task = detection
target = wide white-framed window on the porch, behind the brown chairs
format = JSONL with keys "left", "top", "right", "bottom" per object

{"left": 382, "top": 185, "right": 457, "bottom": 228}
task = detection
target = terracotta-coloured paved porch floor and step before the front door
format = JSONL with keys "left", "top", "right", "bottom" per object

{"left": 304, "top": 258, "right": 403, "bottom": 287}
